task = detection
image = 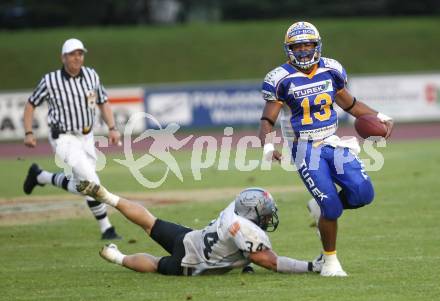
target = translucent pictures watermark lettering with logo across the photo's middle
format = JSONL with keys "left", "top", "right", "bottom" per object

{"left": 55, "top": 112, "right": 386, "bottom": 188}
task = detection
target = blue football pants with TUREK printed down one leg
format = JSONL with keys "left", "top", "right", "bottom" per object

{"left": 292, "top": 141, "right": 374, "bottom": 220}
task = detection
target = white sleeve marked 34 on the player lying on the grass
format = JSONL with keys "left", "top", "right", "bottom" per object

{"left": 230, "top": 222, "right": 272, "bottom": 257}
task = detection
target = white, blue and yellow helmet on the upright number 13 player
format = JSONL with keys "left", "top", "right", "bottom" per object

{"left": 284, "top": 21, "right": 322, "bottom": 69}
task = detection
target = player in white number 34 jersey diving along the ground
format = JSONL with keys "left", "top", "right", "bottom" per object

{"left": 77, "top": 181, "right": 322, "bottom": 276}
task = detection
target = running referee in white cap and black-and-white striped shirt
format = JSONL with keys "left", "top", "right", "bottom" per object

{"left": 23, "top": 39, "right": 121, "bottom": 239}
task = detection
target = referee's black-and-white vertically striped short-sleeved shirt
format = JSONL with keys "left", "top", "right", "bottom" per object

{"left": 29, "top": 67, "right": 107, "bottom": 132}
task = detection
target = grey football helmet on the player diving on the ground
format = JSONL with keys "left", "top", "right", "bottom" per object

{"left": 235, "top": 187, "right": 279, "bottom": 232}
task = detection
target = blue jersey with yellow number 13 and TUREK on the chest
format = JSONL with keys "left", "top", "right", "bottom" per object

{"left": 262, "top": 58, "right": 347, "bottom": 140}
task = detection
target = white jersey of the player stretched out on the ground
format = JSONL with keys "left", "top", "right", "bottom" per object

{"left": 182, "top": 202, "right": 272, "bottom": 275}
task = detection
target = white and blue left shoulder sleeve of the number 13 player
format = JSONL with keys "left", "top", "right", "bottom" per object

{"left": 261, "top": 67, "right": 288, "bottom": 103}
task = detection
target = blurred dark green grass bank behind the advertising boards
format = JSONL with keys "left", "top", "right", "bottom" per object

{"left": 0, "top": 17, "right": 440, "bottom": 90}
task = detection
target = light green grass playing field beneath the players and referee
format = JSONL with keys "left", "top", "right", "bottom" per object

{"left": 0, "top": 140, "right": 440, "bottom": 301}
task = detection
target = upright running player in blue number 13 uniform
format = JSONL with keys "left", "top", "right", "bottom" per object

{"left": 259, "top": 22, "right": 393, "bottom": 276}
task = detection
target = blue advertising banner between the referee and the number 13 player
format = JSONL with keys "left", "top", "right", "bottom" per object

{"left": 145, "top": 82, "right": 264, "bottom": 127}
